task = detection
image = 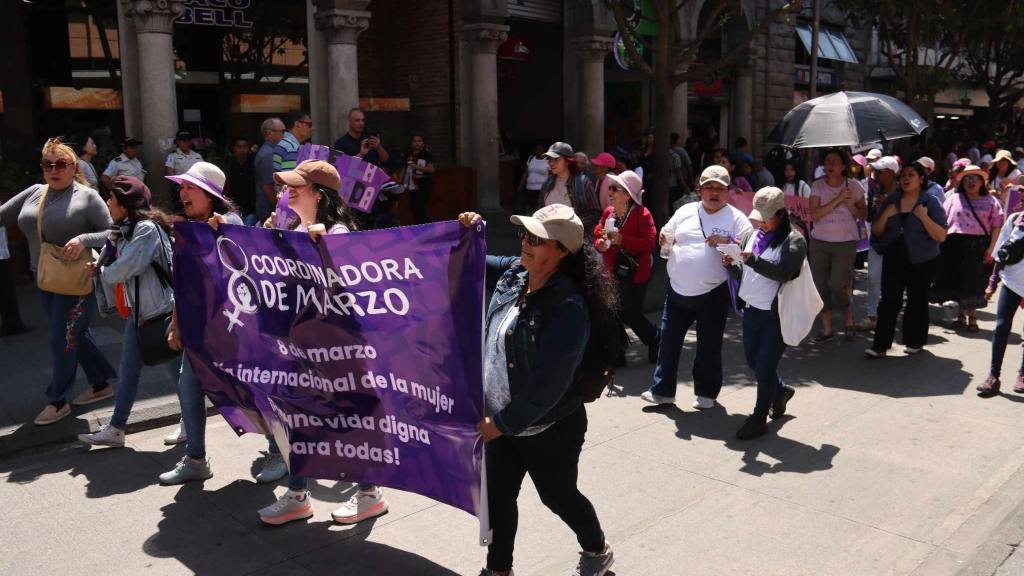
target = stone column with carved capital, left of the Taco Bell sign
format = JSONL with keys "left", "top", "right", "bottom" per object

{"left": 131, "top": 0, "right": 185, "bottom": 205}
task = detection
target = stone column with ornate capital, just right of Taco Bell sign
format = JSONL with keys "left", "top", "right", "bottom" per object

{"left": 316, "top": 1, "right": 370, "bottom": 143}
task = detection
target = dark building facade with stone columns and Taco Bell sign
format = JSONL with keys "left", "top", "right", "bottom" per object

{"left": 0, "top": 0, "right": 870, "bottom": 209}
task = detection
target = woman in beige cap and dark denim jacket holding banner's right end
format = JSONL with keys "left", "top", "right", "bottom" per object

{"left": 459, "top": 204, "right": 616, "bottom": 576}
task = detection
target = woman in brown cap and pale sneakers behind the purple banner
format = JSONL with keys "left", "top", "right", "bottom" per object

{"left": 257, "top": 160, "right": 388, "bottom": 525}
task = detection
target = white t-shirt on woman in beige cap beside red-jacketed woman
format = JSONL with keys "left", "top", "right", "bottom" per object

{"left": 663, "top": 202, "right": 753, "bottom": 296}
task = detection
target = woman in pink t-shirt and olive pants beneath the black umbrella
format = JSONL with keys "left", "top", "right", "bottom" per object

{"left": 809, "top": 149, "right": 867, "bottom": 343}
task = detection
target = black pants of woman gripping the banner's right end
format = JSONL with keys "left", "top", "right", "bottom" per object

{"left": 483, "top": 406, "right": 604, "bottom": 571}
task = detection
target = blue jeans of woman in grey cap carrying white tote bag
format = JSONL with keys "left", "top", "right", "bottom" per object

{"left": 743, "top": 306, "right": 785, "bottom": 417}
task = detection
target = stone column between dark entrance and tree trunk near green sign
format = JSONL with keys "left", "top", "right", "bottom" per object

{"left": 572, "top": 36, "right": 612, "bottom": 156}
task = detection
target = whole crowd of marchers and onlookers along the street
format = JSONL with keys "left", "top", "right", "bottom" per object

{"left": 0, "top": 118, "right": 1024, "bottom": 576}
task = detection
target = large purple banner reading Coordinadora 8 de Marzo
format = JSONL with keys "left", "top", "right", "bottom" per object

{"left": 174, "top": 221, "right": 485, "bottom": 519}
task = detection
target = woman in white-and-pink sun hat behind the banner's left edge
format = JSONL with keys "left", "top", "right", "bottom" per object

{"left": 160, "top": 162, "right": 242, "bottom": 485}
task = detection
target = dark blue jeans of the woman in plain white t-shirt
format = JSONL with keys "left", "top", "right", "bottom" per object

{"left": 650, "top": 282, "right": 731, "bottom": 398}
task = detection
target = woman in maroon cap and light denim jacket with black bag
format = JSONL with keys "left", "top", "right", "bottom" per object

{"left": 78, "top": 176, "right": 179, "bottom": 448}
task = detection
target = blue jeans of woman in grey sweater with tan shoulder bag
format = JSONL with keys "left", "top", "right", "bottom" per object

{"left": 39, "top": 290, "right": 118, "bottom": 404}
